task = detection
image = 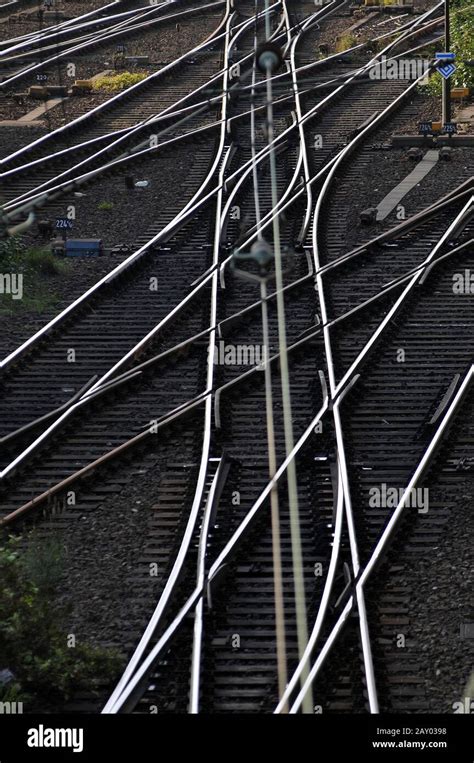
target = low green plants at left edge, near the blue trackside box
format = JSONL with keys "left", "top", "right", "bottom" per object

{"left": 0, "top": 236, "right": 71, "bottom": 315}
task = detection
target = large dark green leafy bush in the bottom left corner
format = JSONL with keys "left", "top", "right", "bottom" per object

{"left": 0, "top": 537, "right": 120, "bottom": 712}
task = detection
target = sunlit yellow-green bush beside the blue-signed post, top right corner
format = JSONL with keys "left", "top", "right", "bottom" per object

{"left": 426, "top": 0, "right": 474, "bottom": 95}
